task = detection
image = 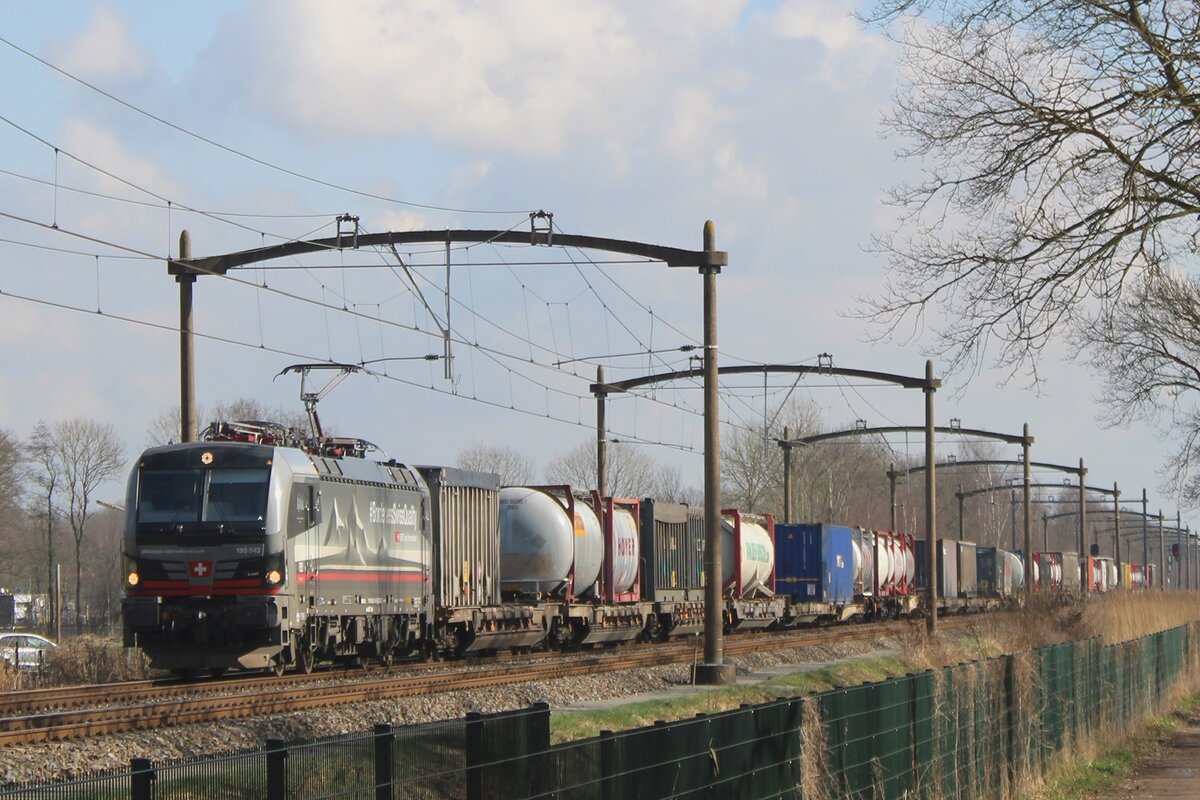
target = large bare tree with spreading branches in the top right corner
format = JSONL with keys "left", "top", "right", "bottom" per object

{"left": 859, "top": 0, "right": 1200, "bottom": 380}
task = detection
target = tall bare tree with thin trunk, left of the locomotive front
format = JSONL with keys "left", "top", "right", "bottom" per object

{"left": 50, "top": 419, "right": 125, "bottom": 628}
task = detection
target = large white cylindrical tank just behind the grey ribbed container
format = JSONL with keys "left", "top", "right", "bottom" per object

{"left": 500, "top": 486, "right": 604, "bottom": 597}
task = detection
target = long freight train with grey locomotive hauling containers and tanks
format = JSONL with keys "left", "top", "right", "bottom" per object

{"left": 122, "top": 422, "right": 1024, "bottom": 675}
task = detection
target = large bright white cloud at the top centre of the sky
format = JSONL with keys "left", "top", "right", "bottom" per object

{"left": 217, "top": 0, "right": 655, "bottom": 155}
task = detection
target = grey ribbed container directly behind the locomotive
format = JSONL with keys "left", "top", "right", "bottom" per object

{"left": 418, "top": 467, "right": 500, "bottom": 608}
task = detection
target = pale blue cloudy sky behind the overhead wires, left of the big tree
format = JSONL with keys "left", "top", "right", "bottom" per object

{"left": 0, "top": 0, "right": 1174, "bottom": 525}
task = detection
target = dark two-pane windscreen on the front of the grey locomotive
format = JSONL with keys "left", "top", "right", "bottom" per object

{"left": 138, "top": 467, "right": 270, "bottom": 524}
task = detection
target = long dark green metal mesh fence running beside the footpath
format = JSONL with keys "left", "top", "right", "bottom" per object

{"left": 0, "top": 624, "right": 1200, "bottom": 800}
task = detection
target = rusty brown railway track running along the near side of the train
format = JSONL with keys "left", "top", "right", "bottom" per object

{"left": 0, "top": 618, "right": 970, "bottom": 746}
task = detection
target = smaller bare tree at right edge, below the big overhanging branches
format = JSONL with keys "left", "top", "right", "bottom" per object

{"left": 1079, "top": 271, "right": 1200, "bottom": 505}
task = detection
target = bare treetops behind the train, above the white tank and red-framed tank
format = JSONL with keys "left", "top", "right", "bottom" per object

{"left": 545, "top": 440, "right": 686, "bottom": 501}
